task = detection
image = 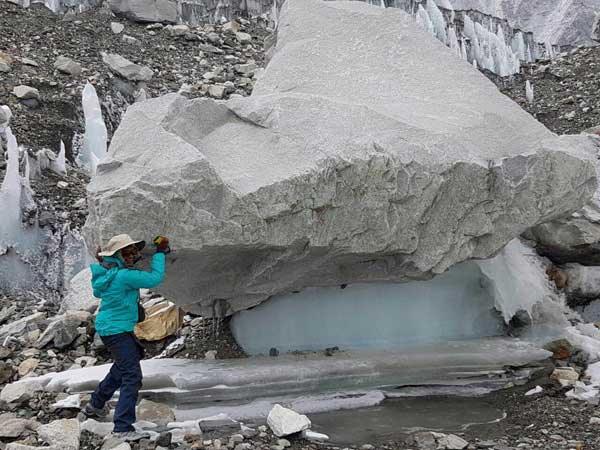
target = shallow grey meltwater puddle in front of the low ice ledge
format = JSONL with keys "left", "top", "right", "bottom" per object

{"left": 310, "top": 396, "right": 504, "bottom": 444}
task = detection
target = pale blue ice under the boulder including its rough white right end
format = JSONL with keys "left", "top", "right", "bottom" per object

{"left": 231, "top": 240, "right": 560, "bottom": 354}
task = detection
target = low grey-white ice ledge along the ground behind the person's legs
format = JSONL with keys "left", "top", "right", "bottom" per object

{"left": 10, "top": 338, "right": 550, "bottom": 420}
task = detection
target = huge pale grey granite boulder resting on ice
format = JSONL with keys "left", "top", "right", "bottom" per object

{"left": 85, "top": 0, "right": 596, "bottom": 315}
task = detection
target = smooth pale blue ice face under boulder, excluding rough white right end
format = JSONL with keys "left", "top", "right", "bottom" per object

{"left": 232, "top": 263, "right": 503, "bottom": 354}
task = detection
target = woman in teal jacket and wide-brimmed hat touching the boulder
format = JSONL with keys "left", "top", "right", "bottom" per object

{"left": 83, "top": 234, "right": 170, "bottom": 440}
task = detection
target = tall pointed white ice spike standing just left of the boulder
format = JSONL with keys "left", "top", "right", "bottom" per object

{"left": 78, "top": 83, "right": 108, "bottom": 175}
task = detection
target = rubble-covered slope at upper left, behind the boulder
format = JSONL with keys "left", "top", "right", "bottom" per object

{"left": 0, "top": 0, "right": 270, "bottom": 155}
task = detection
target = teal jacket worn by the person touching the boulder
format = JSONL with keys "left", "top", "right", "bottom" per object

{"left": 91, "top": 253, "right": 165, "bottom": 336}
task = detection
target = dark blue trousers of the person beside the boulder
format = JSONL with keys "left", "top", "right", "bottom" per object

{"left": 92, "top": 333, "right": 143, "bottom": 433}
